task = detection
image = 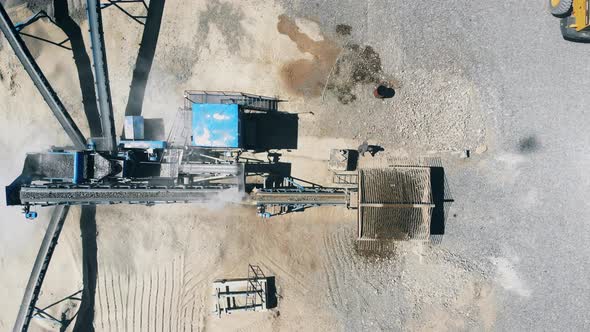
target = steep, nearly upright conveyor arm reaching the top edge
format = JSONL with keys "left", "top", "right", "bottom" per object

{"left": 86, "top": 0, "right": 117, "bottom": 152}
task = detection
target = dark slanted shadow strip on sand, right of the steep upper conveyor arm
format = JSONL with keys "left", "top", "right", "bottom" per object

{"left": 125, "top": 0, "right": 165, "bottom": 115}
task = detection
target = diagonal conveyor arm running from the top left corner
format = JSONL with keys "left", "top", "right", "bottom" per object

{"left": 0, "top": 3, "right": 86, "bottom": 149}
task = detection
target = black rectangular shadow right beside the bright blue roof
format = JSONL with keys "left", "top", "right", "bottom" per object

{"left": 244, "top": 112, "right": 299, "bottom": 152}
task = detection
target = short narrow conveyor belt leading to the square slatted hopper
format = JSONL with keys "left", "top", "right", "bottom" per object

{"left": 254, "top": 191, "right": 348, "bottom": 205}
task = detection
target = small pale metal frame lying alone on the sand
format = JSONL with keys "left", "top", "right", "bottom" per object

{"left": 213, "top": 264, "right": 268, "bottom": 317}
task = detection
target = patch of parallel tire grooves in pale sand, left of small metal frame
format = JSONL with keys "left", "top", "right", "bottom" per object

{"left": 95, "top": 256, "right": 194, "bottom": 332}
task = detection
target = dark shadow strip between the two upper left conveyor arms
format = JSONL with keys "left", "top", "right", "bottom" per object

{"left": 53, "top": 0, "right": 102, "bottom": 137}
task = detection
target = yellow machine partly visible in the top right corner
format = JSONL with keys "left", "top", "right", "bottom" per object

{"left": 549, "top": 0, "right": 590, "bottom": 43}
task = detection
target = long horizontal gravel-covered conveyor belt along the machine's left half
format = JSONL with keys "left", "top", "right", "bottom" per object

{"left": 20, "top": 187, "right": 237, "bottom": 205}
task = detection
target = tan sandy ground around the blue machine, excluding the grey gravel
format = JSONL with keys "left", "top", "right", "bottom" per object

{"left": 0, "top": 1, "right": 495, "bottom": 331}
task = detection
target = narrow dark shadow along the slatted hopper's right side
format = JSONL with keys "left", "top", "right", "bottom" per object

{"left": 430, "top": 167, "right": 453, "bottom": 243}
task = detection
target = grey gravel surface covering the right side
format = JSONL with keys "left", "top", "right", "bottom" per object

{"left": 283, "top": 0, "right": 590, "bottom": 331}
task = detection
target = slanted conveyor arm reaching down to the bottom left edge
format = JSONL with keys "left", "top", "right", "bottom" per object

{"left": 13, "top": 206, "right": 69, "bottom": 332}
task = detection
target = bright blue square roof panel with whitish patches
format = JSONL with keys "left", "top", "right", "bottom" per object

{"left": 192, "top": 104, "right": 240, "bottom": 148}
